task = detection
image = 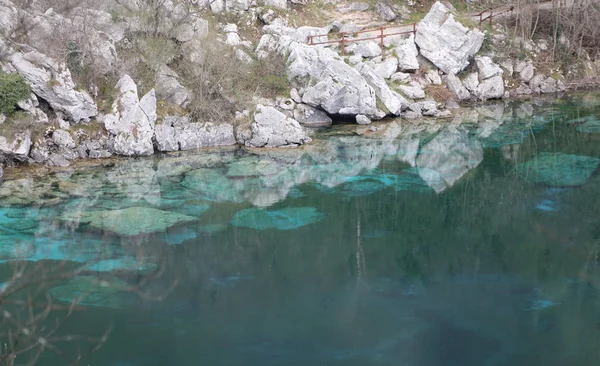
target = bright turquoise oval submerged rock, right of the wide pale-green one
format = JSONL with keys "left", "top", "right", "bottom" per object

{"left": 231, "top": 207, "right": 325, "bottom": 230}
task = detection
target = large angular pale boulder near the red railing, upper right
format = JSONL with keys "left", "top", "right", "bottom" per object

{"left": 415, "top": 1, "right": 484, "bottom": 75}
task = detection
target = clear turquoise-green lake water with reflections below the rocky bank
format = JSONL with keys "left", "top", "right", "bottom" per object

{"left": 0, "top": 94, "right": 600, "bottom": 366}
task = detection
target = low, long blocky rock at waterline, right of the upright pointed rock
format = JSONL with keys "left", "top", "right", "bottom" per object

{"left": 154, "top": 116, "right": 236, "bottom": 151}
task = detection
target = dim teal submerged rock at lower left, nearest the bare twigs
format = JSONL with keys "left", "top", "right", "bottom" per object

{"left": 50, "top": 276, "right": 130, "bottom": 309}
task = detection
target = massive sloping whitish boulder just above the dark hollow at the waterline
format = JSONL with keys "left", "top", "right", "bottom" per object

{"left": 287, "top": 42, "right": 378, "bottom": 117}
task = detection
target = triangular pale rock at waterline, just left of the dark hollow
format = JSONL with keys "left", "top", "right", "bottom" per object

{"left": 245, "top": 104, "right": 311, "bottom": 147}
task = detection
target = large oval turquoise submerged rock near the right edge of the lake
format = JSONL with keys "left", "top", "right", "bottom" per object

{"left": 517, "top": 152, "right": 600, "bottom": 187}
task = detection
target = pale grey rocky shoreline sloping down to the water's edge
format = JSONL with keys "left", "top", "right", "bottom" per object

{"left": 0, "top": 0, "right": 600, "bottom": 177}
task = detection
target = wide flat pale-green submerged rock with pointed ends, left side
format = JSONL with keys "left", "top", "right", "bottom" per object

{"left": 61, "top": 207, "right": 197, "bottom": 236}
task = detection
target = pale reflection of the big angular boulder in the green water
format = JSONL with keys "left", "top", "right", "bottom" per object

{"left": 417, "top": 129, "right": 483, "bottom": 193}
